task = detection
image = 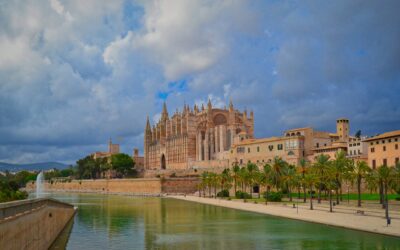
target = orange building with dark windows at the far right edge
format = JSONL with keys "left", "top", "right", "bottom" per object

{"left": 364, "top": 130, "right": 400, "bottom": 169}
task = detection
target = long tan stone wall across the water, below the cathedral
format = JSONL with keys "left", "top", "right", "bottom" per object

{"left": 26, "top": 178, "right": 199, "bottom": 196}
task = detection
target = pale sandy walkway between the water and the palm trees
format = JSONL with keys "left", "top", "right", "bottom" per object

{"left": 168, "top": 195, "right": 400, "bottom": 237}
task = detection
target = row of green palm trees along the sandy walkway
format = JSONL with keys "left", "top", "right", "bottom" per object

{"left": 199, "top": 151, "right": 400, "bottom": 215}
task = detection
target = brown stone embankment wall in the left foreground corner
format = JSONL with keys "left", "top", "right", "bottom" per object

{"left": 0, "top": 198, "right": 75, "bottom": 250}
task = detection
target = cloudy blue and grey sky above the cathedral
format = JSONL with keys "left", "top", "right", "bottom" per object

{"left": 0, "top": 0, "right": 400, "bottom": 163}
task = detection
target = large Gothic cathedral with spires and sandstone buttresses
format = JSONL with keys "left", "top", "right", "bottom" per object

{"left": 144, "top": 100, "right": 254, "bottom": 170}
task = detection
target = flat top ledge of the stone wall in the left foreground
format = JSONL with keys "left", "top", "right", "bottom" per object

{"left": 0, "top": 198, "right": 74, "bottom": 223}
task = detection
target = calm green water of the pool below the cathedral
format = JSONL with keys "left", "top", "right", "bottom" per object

{"left": 48, "top": 194, "right": 400, "bottom": 250}
